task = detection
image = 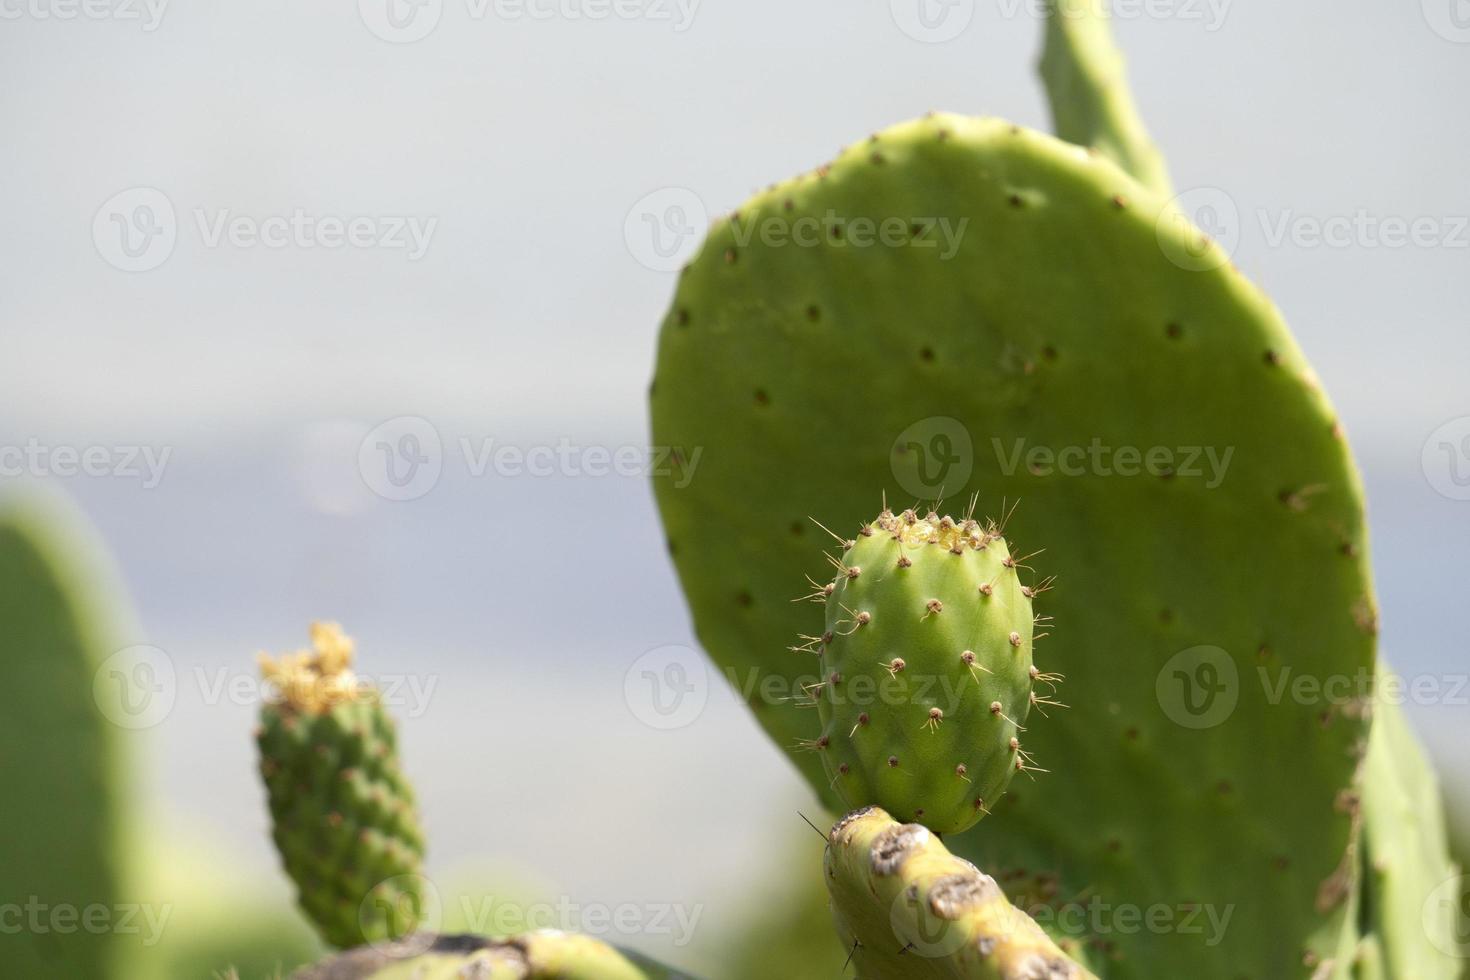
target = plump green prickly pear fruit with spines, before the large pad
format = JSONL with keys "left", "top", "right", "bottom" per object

{"left": 795, "top": 510, "right": 1060, "bottom": 833}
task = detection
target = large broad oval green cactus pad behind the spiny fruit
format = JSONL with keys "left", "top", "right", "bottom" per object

{"left": 651, "top": 115, "right": 1376, "bottom": 980}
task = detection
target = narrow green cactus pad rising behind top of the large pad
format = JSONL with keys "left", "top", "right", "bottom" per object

{"left": 1041, "top": 0, "right": 1172, "bottom": 195}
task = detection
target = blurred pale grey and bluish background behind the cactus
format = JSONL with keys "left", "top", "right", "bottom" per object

{"left": 0, "top": 0, "right": 1470, "bottom": 967}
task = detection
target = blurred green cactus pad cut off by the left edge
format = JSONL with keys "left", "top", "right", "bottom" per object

{"left": 0, "top": 498, "right": 140, "bottom": 980}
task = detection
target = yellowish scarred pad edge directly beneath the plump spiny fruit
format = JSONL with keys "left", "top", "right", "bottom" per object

{"left": 823, "top": 807, "right": 1095, "bottom": 980}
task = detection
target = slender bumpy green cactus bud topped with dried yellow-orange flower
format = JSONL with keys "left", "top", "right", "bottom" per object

{"left": 256, "top": 623, "right": 423, "bottom": 948}
